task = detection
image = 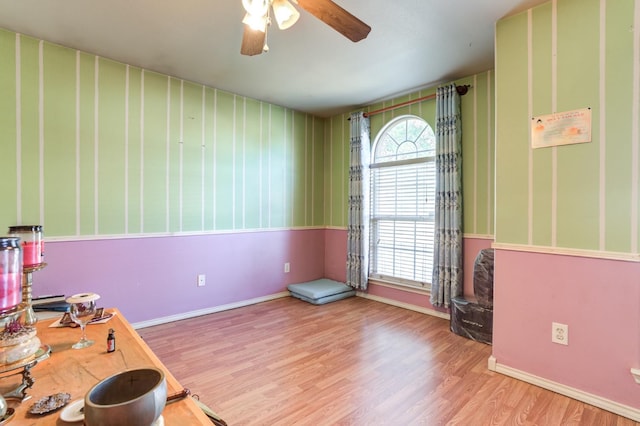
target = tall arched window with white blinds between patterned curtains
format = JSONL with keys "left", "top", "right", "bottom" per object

{"left": 369, "top": 116, "right": 436, "bottom": 288}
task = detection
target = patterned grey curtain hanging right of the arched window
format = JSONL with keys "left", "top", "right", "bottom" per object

{"left": 431, "top": 84, "right": 463, "bottom": 308}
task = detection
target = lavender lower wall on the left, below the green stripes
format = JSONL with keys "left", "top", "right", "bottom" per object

{"left": 33, "top": 229, "right": 325, "bottom": 323}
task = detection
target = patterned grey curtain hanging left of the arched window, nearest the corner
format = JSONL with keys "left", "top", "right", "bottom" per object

{"left": 347, "top": 112, "right": 371, "bottom": 290}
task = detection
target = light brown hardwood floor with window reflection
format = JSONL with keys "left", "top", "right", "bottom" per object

{"left": 139, "top": 297, "right": 638, "bottom": 426}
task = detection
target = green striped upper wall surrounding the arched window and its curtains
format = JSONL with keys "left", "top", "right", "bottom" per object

{"left": 325, "top": 71, "right": 495, "bottom": 237}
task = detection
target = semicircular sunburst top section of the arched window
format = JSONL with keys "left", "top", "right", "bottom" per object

{"left": 371, "top": 115, "right": 436, "bottom": 163}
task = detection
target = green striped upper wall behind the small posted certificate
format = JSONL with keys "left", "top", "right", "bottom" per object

{"left": 496, "top": 0, "right": 640, "bottom": 253}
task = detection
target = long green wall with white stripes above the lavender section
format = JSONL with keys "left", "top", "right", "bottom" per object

{"left": 0, "top": 30, "right": 325, "bottom": 237}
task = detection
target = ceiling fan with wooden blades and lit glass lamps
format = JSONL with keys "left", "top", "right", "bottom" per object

{"left": 240, "top": 0, "right": 371, "bottom": 56}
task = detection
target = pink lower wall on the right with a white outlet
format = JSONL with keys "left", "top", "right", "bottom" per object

{"left": 493, "top": 250, "right": 640, "bottom": 408}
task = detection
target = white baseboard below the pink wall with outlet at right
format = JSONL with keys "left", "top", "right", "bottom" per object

{"left": 488, "top": 355, "right": 640, "bottom": 422}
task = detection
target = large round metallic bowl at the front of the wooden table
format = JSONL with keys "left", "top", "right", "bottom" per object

{"left": 84, "top": 368, "right": 167, "bottom": 426}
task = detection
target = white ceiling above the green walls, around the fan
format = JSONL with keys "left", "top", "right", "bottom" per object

{"left": 0, "top": 0, "right": 547, "bottom": 117}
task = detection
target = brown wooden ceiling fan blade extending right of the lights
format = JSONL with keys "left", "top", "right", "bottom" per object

{"left": 297, "top": 0, "right": 371, "bottom": 42}
